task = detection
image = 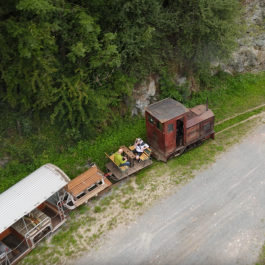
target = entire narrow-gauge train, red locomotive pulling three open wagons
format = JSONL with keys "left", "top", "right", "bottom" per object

{"left": 0, "top": 98, "right": 215, "bottom": 265}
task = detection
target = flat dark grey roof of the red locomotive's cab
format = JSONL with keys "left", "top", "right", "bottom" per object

{"left": 145, "top": 98, "right": 189, "bottom": 123}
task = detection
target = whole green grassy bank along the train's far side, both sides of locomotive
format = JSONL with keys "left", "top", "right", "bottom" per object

{"left": 0, "top": 73, "right": 265, "bottom": 192}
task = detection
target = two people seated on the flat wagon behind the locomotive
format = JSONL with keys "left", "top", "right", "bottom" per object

{"left": 114, "top": 138, "right": 149, "bottom": 167}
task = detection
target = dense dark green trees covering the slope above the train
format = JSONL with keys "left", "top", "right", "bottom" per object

{"left": 0, "top": 0, "right": 239, "bottom": 138}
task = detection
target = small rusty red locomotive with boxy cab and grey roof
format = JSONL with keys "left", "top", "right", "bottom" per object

{"left": 145, "top": 98, "right": 214, "bottom": 162}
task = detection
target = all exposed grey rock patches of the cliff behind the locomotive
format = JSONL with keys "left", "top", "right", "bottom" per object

{"left": 132, "top": 0, "right": 265, "bottom": 115}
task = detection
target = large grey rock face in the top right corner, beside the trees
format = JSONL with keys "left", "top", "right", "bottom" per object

{"left": 220, "top": 0, "right": 265, "bottom": 74}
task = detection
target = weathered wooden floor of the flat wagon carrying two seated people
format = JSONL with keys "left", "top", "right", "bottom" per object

{"left": 106, "top": 159, "right": 153, "bottom": 180}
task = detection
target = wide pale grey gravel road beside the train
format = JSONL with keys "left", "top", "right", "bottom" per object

{"left": 75, "top": 125, "right": 265, "bottom": 265}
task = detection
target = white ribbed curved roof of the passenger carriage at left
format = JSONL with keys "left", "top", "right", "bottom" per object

{"left": 0, "top": 164, "right": 70, "bottom": 233}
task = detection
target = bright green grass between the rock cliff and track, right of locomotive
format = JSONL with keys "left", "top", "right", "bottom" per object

{"left": 187, "top": 72, "right": 265, "bottom": 122}
